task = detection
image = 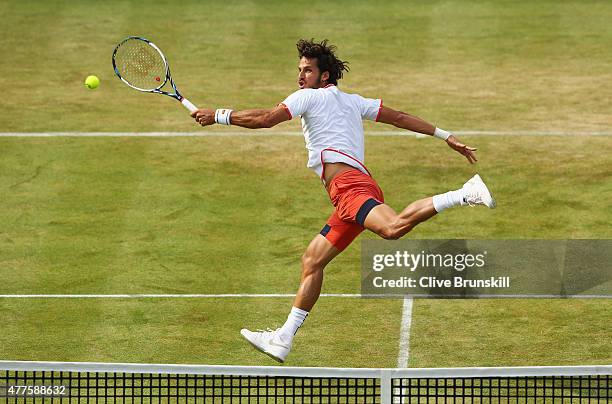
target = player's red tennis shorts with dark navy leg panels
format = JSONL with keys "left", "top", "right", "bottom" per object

{"left": 321, "top": 169, "right": 385, "bottom": 251}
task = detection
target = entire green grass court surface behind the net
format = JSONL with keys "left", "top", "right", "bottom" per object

{"left": 0, "top": 0, "right": 612, "bottom": 367}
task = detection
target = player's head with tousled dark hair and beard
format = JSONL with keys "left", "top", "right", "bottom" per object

{"left": 297, "top": 39, "right": 349, "bottom": 88}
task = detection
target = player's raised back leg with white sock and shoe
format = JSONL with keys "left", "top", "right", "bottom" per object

{"left": 363, "top": 175, "right": 495, "bottom": 240}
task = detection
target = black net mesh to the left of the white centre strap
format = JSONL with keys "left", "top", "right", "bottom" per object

{"left": 0, "top": 371, "right": 380, "bottom": 403}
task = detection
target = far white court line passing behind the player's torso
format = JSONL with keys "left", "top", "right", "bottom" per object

{"left": 0, "top": 130, "right": 612, "bottom": 137}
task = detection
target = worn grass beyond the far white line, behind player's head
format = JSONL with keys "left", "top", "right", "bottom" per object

{"left": 0, "top": 1, "right": 612, "bottom": 131}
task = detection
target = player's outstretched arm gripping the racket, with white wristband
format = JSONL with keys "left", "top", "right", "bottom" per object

{"left": 191, "top": 105, "right": 291, "bottom": 129}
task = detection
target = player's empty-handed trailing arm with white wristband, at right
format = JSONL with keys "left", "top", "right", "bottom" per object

{"left": 377, "top": 106, "right": 478, "bottom": 164}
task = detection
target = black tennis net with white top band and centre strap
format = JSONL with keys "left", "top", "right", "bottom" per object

{"left": 0, "top": 361, "right": 612, "bottom": 404}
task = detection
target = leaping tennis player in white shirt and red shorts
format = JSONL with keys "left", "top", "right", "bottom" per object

{"left": 191, "top": 39, "right": 495, "bottom": 362}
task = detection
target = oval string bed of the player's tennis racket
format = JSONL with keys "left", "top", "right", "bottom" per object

{"left": 115, "top": 39, "right": 166, "bottom": 90}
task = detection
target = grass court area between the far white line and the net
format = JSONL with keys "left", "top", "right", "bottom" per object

{"left": 0, "top": 136, "right": 612, "bottom": 367}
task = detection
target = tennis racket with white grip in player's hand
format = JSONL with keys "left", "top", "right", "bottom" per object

{"left": 113, "top": 36, "right": 198, "bottom": 112}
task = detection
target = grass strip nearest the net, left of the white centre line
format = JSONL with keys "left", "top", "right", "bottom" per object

{"left": 0, "top": 296, "right": 401, "bottom": 367}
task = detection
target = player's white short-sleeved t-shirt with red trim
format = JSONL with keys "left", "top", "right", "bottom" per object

{"left": 281, "top": 84, "right": 382, "bottom": 177}
